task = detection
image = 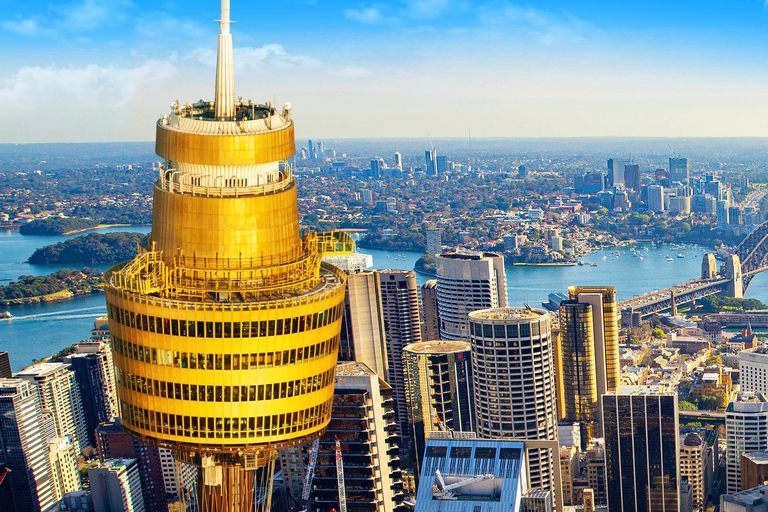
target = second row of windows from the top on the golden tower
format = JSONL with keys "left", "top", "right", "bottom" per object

{"left": 112, "top": 335, "right": 339, "bottom": 370}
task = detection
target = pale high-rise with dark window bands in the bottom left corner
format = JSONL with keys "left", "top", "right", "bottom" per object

{"left": 0, "top": 379, "right": 56, "bottom": 512}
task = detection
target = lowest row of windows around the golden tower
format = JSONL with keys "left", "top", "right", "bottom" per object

{"left": 120, "top": 401, "right": 329, "bottom": 439}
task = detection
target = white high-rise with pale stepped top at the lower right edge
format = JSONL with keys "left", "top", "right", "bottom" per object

{"left": 725, "top": 391, "right": 768, "bottom": 493}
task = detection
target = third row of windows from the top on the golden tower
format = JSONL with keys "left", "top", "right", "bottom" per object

{"left": 117, "top": 369, "right": 335, "bottom": 402}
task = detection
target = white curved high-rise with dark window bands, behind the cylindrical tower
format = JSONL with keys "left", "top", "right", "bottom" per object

{"left": 436, "top": 252, "right": 507, "bottom": 341}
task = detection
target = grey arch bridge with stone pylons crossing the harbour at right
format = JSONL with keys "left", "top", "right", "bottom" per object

{"left": 619, "top": 221, "right": 768, "bottom": 325}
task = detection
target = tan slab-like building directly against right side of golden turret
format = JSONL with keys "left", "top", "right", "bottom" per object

{"left": 339, "top": 270, "right": 389, "bottom": 379}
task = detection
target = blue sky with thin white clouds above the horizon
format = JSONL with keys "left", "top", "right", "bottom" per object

{"left": 0, "top": 0, "right": 768, "bottom": 143}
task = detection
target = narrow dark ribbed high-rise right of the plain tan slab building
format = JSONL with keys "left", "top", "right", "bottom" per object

{"left": 377, "top": 270, "right": 422, "bottom": 450}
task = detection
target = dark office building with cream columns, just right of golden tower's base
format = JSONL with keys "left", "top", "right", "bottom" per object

{"left": 309, "top": 362, "right": 406, "bottom": 512}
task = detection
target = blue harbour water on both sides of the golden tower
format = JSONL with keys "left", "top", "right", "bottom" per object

{"left": 0, "top": 227, "right": 768, "bottom": 371}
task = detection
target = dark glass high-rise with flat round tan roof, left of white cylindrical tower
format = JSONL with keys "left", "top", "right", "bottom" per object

{"left": 403, "top": 341, "right": 475, "bottom": 469}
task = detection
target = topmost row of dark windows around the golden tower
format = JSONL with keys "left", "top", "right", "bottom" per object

{"left": 107, "top": 304, "right": 343, "bottom": 338}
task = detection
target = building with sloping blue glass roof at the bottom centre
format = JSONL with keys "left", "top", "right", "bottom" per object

{"left": 415, "top": 432, "right": 528, "bottom": 512}
